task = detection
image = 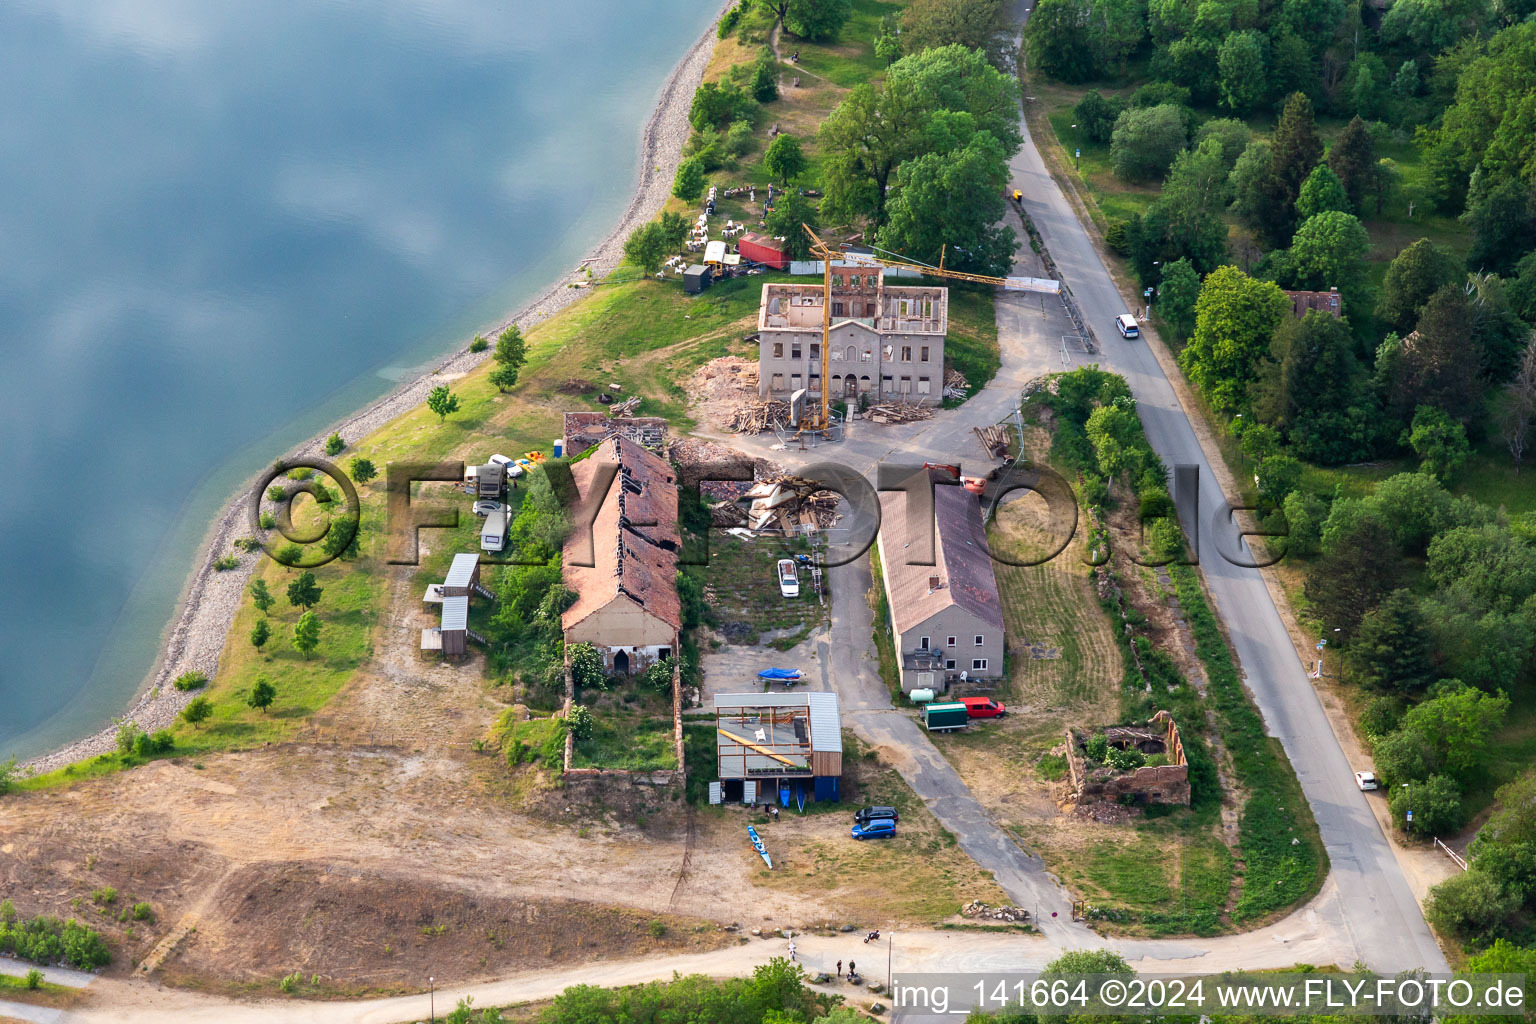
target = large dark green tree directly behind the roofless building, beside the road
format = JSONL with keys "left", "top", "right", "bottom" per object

{"left": 879, "top": 132, "right": 1017, "bottom": 275}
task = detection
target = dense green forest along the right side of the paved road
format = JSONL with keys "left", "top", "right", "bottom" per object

{"left": 1025, "top": 0, "right": 1536, "bottom": 946}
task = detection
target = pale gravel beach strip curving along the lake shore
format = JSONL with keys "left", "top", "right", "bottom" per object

{"left": 22, "top": 6, "right": 725, "bottom": 774}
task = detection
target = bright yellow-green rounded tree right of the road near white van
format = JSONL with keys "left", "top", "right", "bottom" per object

{"left": 1178, "top": 267, "right": 1290, "bottom": 416}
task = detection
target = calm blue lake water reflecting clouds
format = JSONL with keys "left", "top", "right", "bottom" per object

{"left": 0, "top": 0, "right": 719, "bottom": 758}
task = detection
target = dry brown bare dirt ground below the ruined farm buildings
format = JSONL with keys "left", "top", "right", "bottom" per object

{"left": 0, "top": 552, "right": 989, "bottom": 995}
